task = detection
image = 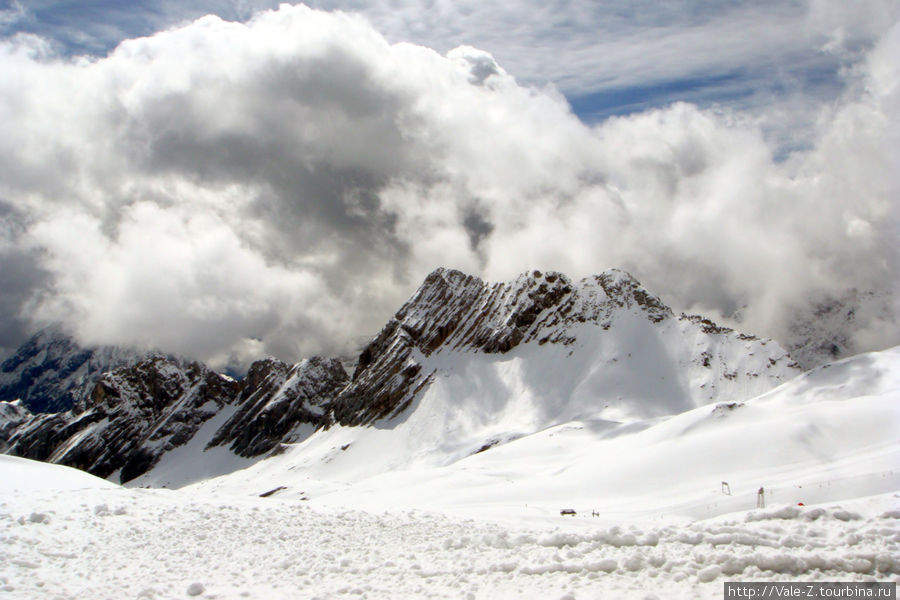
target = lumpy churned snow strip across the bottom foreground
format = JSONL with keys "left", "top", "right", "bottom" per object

{"left": 0, "top": 488, "right": 900, "bottom": 600}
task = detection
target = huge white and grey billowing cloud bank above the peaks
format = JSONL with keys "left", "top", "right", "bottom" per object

{"left": 0, "top": 6, "right": 900, "bottom": 366}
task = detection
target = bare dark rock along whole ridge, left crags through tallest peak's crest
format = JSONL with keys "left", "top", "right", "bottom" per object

{"left": 0, "top": 269, "right": 799, "bottom": 483}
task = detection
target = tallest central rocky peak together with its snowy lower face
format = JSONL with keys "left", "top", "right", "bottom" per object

{"left": 323, "top": 269, "right": 800, "bottom": 472}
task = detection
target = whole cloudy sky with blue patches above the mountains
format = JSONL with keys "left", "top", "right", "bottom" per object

{"left": 0, "top": 0, "right": 900, "bottom": 369}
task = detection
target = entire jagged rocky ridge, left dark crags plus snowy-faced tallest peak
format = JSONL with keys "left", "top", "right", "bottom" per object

{"left": 0, "top": 269, "right": 800, "bottom": 482}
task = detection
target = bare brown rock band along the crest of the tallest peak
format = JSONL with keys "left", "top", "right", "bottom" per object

{"left": 333, "top": 269, "right": 800, "bottom": 425}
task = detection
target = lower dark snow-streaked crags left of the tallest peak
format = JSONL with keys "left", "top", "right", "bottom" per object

{"left": 0, "top": 355, "right": 348, "bottom": 483}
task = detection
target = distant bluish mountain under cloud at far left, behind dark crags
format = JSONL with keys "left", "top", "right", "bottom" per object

{"left": 0, "top": 327, "right": 144, "bottom": 413}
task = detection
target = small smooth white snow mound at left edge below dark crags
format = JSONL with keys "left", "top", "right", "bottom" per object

{"left": 0, "top": 455, "right": 118, "bottom": 495}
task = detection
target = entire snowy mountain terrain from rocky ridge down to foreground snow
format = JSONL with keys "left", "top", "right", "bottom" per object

{"left": 0, "top": 270, "right": 900, "bottom": 600}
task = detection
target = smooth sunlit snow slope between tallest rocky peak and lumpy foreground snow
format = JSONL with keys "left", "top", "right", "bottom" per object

{"left": 190, "top": 348, "right": 900, "bottom": 521}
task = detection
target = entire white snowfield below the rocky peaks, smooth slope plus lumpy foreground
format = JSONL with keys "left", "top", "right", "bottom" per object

{"left": 7, "top": 348, "right": 900, "bottom": 600}
